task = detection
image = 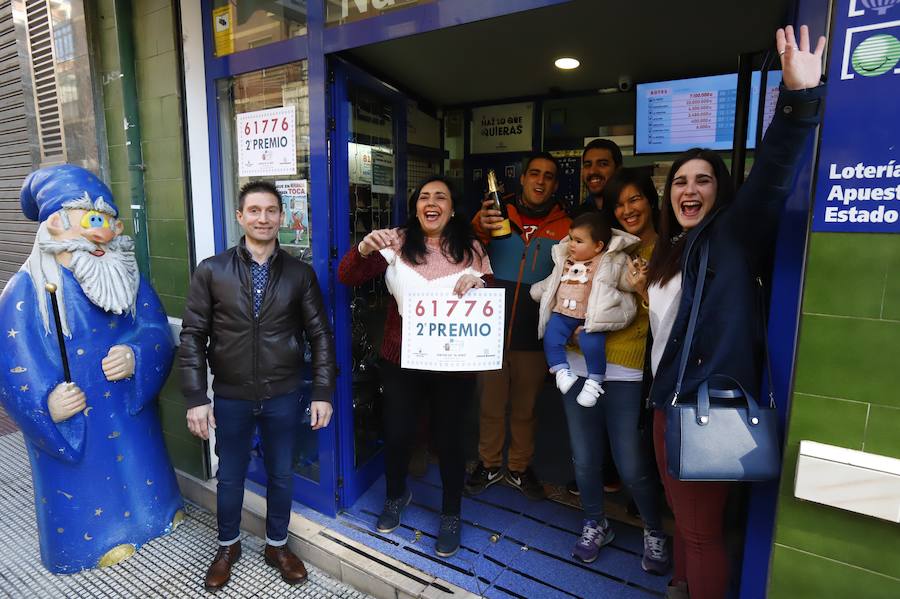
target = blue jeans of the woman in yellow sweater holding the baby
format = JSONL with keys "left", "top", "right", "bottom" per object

{"left": 563, "top": 377, "right": 662, "bottom": 530}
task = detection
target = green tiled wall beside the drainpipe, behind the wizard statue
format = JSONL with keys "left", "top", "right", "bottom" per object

{"left": 95, "top": 0, "right": 207, "bottom": 478}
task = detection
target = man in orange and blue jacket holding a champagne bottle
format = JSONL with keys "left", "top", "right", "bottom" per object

{"left": 465, "top": 152, "right": 571, "bottom": 499}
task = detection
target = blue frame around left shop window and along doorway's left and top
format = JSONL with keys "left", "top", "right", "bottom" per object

{"left": 201, "top": 0, "right": 568, "bottom": 515}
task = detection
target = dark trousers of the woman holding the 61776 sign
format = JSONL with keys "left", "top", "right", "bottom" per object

{"left": 381, "top": 360, "right": 475, "bottom": 514}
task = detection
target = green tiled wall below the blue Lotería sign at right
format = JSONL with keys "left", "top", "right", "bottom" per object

{"left": 768, "top": 233, "right": 900, "bottom": 599}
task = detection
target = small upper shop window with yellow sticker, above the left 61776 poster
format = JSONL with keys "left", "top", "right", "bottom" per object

{"left": 212, "top": 0, "right": 306, "bottom": 56}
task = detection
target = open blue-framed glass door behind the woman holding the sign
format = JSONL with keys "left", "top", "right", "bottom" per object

{"left": 331, "top": 60, "right": 406, "bottom": 507}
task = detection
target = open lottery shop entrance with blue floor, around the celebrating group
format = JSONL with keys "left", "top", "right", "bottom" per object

{"left": 318, "top": 0, "right": 825, "bottom": 597}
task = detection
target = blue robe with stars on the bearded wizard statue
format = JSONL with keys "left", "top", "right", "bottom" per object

{"left": 0, "top": 268, "right": 183, "bottom": 574}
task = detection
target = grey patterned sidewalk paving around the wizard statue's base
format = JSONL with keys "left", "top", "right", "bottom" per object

{"left": 0, "top": 426, "right": 369, "bottom": 599}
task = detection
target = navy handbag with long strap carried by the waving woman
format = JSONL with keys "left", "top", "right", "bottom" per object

{"left": 666, "top": 243, "right": 781, "bottom": 481}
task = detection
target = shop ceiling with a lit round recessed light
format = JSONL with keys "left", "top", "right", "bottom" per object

{"left": 346, "top": 0, "right": 791, "bottom": 106}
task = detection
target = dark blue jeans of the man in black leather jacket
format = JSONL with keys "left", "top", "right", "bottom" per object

{"left": 213, "top": 389, "right": 300, "bottom": 545}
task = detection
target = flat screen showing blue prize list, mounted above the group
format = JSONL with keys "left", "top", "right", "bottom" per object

{"left": 634, "top": 71, "right": 781, "bottom": 154}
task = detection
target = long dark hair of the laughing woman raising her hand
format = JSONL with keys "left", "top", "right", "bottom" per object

{"left": 647, "top": 148, "right": 734, "bottom": 285}
